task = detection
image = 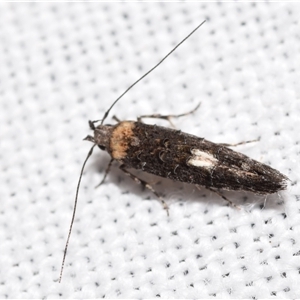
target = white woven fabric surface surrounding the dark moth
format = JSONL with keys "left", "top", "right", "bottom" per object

{"left": 0, "top": 3, "right": 300, "bottom": 298}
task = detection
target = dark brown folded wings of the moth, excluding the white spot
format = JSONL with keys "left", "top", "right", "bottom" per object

{"left": 122, "top": 122, "right": 287, "bottom": 194}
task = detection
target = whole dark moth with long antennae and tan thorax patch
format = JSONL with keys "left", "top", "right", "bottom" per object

{"left": 59, "top": 21, "right": 288, "bottom": 282}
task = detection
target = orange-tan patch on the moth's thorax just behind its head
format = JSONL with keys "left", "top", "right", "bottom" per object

{"left": 110, "top": 121, "right": 137, "bottom": 159}
